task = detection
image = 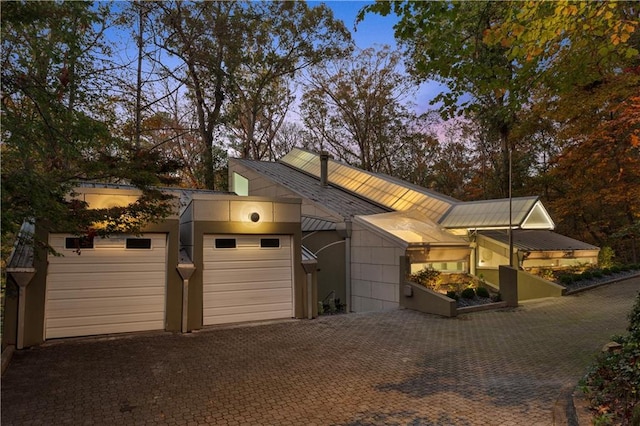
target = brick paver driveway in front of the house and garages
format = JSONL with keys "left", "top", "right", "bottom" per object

{"left": 2, "top": 278, "right": 640, "bottom": 426}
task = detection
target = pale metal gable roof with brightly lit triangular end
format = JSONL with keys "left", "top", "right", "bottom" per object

{"left": 439, "top": 197, "right": 555, "bottom": 229}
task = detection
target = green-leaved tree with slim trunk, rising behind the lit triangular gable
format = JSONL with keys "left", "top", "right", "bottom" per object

{"left": 358, "top": 1, "right": 535, "bottom": 196}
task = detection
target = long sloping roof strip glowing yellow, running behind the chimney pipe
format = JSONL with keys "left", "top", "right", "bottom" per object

{"left": 280, "top": 148, "right": 459, "bottom": 220}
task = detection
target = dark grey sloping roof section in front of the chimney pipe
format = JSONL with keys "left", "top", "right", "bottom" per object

{"left": 236, "top": 159, "right": 390, "bottom": 218}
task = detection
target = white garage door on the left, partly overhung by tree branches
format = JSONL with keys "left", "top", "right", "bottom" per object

{"left": 45, "top": 234, "right": 167, "bottom": 339}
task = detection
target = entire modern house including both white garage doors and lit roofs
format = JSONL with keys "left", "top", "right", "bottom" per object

{"left": 2, "top": 149, "right": 599, "bottom": 349}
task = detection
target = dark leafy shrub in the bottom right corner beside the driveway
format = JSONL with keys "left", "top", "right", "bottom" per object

{"left": 581, "top": 293, "right": 640, "bottom": 425}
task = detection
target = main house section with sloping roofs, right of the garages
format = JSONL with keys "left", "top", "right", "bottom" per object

{"left": 229, "top": 148, "right": 599, "bottom": 312}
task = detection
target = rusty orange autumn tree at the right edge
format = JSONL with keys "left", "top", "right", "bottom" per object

{"left": 536, "top": 84, "right": 640, "bottom": 262}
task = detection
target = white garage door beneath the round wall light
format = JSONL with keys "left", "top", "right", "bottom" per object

{"left": 203, "top": 235, "right": 294, "bottom": 325}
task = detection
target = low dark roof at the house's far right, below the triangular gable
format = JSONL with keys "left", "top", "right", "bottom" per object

{"left": 478, "top": 229, "right": 599, "bottom": 251}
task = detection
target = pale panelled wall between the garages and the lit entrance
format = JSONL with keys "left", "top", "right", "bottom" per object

{"left": 351, "top": 221, "right": 405, "bottom": 312}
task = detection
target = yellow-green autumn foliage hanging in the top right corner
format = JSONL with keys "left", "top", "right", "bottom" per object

{"left": 484, "top": 0, "right": 640, "bottom": 93}
